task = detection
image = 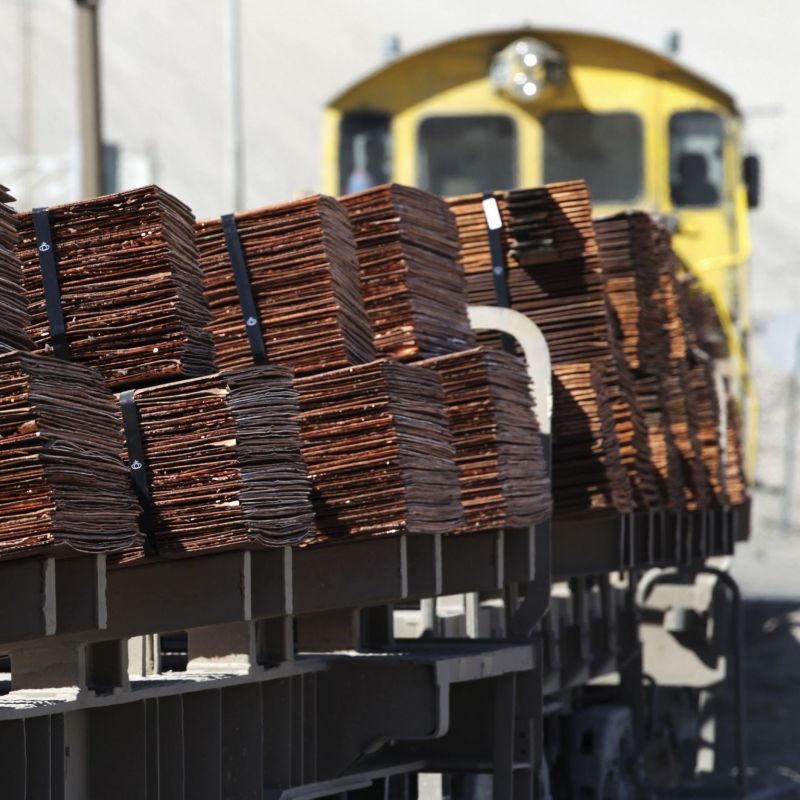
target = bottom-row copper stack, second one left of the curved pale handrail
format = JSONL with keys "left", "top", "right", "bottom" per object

{"left": 295, "top": 361, "right": 464, "bottom": 541}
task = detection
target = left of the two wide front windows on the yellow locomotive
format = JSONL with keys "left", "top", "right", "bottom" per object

{"left": 417, "top": 115, "right": 517, "bottom": 197}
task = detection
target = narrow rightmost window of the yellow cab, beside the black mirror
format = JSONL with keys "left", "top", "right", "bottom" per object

{"left": 669, "top": 111, "right": 725, "bottom": 208}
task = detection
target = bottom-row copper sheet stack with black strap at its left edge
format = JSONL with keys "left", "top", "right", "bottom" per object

{"left": 123, "top": 366, "right": 313, "bottom": 557}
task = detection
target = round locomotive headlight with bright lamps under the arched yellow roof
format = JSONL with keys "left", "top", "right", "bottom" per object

{"left": 489, "top": 37, "right": 566, "bottom": 103}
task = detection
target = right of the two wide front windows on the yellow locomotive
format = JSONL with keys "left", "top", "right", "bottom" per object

{"left": 542, "top": 111, "right": 644, "bottom": 203}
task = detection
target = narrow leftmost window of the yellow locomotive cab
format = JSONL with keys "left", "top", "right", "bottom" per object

{"left": 339, "top": 111, "right": 391, "bottom": 194}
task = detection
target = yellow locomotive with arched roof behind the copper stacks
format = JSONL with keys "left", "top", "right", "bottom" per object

{"left": 323, "top": 29, "right": 758, "bottom": 469}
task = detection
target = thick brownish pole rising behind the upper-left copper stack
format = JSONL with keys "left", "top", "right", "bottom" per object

{"left": 75, "top": 0, "right": 103, "bottom": 199}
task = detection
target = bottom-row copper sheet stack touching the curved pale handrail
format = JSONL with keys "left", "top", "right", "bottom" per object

{"left": 421, "top": 347, "right": 552, "bottom": 531}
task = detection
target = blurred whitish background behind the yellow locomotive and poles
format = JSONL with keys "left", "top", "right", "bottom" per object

{"left": 0, "top": 0, "right": 800, "bottom": 588}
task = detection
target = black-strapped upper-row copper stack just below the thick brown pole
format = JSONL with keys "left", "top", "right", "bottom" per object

{"left": 18, "top": 186, "right": 214, "bottom": 388}
